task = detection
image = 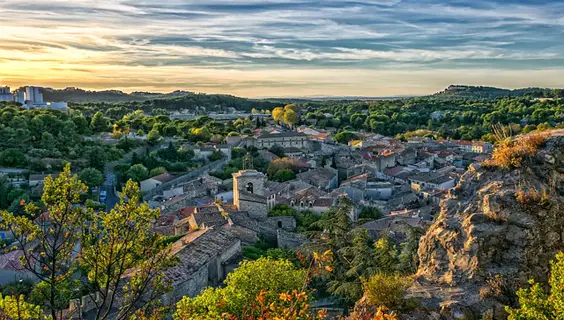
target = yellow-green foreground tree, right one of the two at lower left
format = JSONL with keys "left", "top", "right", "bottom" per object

{"left": 80, "top": 180, "right": 176, "bottom": 320}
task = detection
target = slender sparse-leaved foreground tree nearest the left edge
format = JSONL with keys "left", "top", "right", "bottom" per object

{"left": 2, "top": 165, "right": 88, "bottom": 319}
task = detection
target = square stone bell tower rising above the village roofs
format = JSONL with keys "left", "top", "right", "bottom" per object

{"left": 233, "top": 170, "right": 268, "bottom": 220}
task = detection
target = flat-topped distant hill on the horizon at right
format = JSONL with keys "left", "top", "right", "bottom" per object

{"left": 432, "top": 85, "right": 564, "bottom": 99}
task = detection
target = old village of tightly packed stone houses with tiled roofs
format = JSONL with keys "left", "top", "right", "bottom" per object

{"left": 0, "top": 111, "right": 493, "bottom": 314}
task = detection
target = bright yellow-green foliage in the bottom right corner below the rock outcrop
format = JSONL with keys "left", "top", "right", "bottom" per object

{"left": 506, "top": 252, "right": 564, "bottom": 320}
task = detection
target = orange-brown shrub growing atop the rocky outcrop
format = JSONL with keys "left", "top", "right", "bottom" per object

{"left": 487, "top": 133, "right": 548, "bottom": 169}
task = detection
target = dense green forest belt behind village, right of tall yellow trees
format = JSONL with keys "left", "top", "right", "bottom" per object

{"left": 305, "top": 97, "right": 564, "bottom": 141}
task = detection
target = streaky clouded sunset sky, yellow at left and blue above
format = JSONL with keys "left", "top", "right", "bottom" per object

{"left": 0, "top": 0, "right": 564, "bottom": 97}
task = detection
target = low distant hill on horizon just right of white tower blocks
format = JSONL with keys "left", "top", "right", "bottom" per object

{"left": 39, "top": 87, "right": 192, "bottom": 102}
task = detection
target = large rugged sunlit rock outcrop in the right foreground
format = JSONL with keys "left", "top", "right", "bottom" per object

{"left": 409, "top": 130, "right": 564, "bottom": 319}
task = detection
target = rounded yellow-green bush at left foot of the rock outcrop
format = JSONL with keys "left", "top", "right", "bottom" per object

{"left": 363, "top": 273, "right": 411, "bottom": 310}
